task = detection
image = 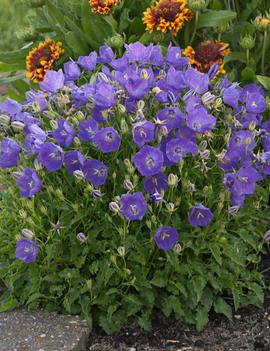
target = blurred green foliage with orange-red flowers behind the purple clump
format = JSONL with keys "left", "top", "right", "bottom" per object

{"left": 0, "top": 0, "right": 270, "bottom": 101}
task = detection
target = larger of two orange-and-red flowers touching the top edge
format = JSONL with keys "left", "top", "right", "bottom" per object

{"left": 143, "top": 0, "right": 192, "bottom": 36}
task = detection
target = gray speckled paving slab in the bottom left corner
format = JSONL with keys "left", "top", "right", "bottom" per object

{"left": 0, "top": 309, "right": 90, "bottom": 351}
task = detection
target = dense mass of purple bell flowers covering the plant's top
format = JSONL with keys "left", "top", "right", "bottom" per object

{"left": 0, "top": 43, "right": 270, "bottom": 263}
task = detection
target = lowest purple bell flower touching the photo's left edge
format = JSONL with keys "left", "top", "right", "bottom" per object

{"left": 0, "top": 138, "right": 21, "bottom": 169}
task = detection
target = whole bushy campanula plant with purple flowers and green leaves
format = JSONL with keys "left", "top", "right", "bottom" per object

{"left": 0, "top": 42, "right": 270, "bottom": 333}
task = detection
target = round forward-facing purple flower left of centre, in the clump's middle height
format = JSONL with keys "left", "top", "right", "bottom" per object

{"left": 93, "top": 127, "right": 121, "bottom": 154}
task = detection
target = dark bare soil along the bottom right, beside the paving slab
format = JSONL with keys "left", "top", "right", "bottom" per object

{"left": 89, "top": 255, "right": 270, "bottom": 351}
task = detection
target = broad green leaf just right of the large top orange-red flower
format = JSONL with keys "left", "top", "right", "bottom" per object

{"left": 197, "top": 10, "right": 237, "bottom": 28}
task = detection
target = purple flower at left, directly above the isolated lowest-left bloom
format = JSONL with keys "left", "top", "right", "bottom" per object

{"left": 17, "top": 168, "right": 42, "bottom": 197}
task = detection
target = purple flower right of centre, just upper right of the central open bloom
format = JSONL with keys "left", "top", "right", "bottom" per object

{"left": 166, "top": 138, "right": 198, "bottom": 163}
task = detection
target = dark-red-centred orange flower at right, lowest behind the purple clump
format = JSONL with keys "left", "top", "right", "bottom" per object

{"left": 183, "top": 40, "right": 230, "bottom": 74}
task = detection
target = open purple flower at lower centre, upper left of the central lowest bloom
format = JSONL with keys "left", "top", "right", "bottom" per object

{"left": 120, "top": 192, "right": 147, "bottom": 221}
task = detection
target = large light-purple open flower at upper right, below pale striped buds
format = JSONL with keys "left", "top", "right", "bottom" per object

{"left": 187, "top": 108, "right": 216, "bottom": 133}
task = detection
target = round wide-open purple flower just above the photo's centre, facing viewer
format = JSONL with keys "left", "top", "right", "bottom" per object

{"left": 133, "top": 145, "right": 164, "bottom": 177}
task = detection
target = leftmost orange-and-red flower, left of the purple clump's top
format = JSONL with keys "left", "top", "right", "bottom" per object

{"left": 26, "top": 38, "right": 64, "bottom": 82}
